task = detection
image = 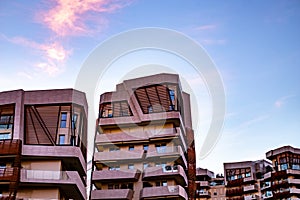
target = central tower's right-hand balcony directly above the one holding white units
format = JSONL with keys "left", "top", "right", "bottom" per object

{"left": 146, "top": 146, "right": 187, "bottom": 167}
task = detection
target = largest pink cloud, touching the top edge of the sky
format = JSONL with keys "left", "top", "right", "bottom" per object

{"left": 41, "top": 0, "right": 130, "bottom": 36}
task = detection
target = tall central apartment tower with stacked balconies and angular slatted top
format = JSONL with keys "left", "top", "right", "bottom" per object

{"left": 91, "top": 74, "right": 196, "bottom": 200}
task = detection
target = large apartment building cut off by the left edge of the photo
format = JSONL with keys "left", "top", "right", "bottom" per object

{"left": 0, "top": 89, "right": 87, "bottom": 200}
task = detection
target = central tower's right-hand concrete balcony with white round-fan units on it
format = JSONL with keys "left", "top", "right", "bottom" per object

{"left": 143, "top": 165, "right": 187, "bottom": 185}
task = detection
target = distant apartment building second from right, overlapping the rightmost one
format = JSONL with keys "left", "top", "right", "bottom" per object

{"left": 224, "top": 160, "right": 272, "bottom": 200}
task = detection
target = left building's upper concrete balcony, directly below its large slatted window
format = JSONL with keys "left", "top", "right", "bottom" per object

{"left": 22, "top": 145, "right": 86, "bottom": 176}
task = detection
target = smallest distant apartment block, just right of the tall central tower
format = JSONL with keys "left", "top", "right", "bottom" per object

{"left": 195, "top": 168, "right": 226, "bottom": 200}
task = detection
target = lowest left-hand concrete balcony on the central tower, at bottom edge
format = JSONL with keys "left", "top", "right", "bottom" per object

{"left": 91, "top": 189, "right": 133, "bottom": 200}
